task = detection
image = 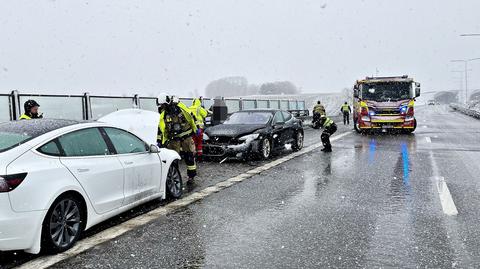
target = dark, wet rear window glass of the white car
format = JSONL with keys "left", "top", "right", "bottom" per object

{"left": 0, "top": 119, "right": 78, "bottom": 152}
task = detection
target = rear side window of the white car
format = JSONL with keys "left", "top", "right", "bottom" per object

{"left": 58, "top": 128, "right": 110, "bottom": 157}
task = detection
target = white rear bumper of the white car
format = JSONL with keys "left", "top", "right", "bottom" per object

{"left": 0, "top": 193, "right": 46, "bottom": 253}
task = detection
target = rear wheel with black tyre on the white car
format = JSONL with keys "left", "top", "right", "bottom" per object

{"left": 42, "top": 194, "right": 86, "bottom": 251}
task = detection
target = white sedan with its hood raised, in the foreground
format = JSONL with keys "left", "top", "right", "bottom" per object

{"left": 0, "top": 109, "right": 182, "bottom": 253}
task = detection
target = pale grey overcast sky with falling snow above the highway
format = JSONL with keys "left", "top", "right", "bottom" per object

{"left": 0, "top": 0, "right": 480, "bottom": 95}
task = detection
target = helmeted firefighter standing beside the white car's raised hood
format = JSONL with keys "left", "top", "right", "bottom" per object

{"left": 157, "top": 95, "right": 198, "bottom": 182}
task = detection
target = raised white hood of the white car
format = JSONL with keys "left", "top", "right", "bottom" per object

{"left": 98, "top": 109, "right": 160, "bottom": 145}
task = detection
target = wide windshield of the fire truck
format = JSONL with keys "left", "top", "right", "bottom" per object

{"left": 362, "top": 82, "right": 411, "bottom": 102}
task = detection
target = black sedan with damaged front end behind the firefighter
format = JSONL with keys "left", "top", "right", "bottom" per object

{"left": 203, "top": 109, "right": 304, "bottom": 159}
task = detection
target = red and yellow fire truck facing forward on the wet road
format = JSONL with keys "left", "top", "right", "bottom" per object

{"left": 353, "top": 75, "right": 420, "bottom": 133}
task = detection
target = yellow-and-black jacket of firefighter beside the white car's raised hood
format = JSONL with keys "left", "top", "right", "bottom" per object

{"left": 157, "top": 102, "right": 197, "bottom": 144}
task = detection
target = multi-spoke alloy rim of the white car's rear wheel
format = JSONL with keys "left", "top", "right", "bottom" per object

{"left": 50, "top": 199, "right": 81, "bottom": 247}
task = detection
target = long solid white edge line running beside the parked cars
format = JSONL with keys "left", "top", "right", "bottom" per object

{"left": 17, "top": 131, "right": 353, "bottom": 269}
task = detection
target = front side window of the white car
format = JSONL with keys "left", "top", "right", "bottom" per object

{"left": 104, "top": 128, "right": 147, "bottom": 154}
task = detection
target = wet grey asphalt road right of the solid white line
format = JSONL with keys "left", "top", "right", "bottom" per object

{"left": 4, "top": 106, "right": 480, "bottom": 268}
